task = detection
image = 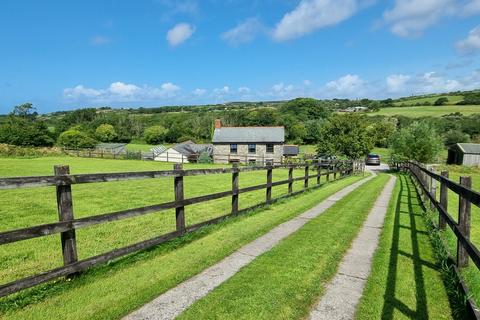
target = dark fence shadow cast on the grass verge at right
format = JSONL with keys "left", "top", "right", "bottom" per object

{"left": 382, "top": 175, "right": 438, "bottom": 320}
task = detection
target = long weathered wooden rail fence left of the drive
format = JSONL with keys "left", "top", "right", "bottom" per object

{"left": 0, "top": 161, "right": 364, "bottom": 297}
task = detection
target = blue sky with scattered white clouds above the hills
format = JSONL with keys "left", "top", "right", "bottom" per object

{"left": 0, "top": 0, "right": 480, "bottom": 113}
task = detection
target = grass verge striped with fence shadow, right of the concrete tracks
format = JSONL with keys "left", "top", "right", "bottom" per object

{"left": 356, "top": 175, "right": 452, "bottom": 319}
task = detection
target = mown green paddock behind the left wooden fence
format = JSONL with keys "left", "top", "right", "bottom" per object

{"left": 0, "top": 157, "right": 314, "bottom": 283}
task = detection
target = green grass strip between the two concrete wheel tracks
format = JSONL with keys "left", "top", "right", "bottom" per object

{"left": 179, "top": 175, "right": 388, "bottom": 319}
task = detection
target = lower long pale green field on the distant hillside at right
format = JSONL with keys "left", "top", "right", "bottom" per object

{"left": 367, "top": 105, "right": 480, "bottom": 118}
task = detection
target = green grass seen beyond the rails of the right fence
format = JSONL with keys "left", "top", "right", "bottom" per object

{"left": 437, "top": 165, "right": 480, "bottom": 305}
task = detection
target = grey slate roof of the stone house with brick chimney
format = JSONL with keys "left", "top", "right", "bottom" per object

{"left": 212, "top": 127, "right": 285, "bottom": 143}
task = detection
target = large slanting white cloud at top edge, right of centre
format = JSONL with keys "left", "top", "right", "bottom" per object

{"left": 273, "top": 0, "right": 359, "bottom": 41}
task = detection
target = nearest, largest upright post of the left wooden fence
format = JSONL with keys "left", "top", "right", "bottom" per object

{"left": 54, "top": 166, "right": 78, "bottom": 272}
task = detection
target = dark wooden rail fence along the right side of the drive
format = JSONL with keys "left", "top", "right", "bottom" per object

{"left": 404, "top": 162, "right": 480, "bottom": 319}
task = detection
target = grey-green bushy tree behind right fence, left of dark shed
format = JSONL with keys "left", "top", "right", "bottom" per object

{"left": 390, "top": 121, "right": 442, "bottom": 163}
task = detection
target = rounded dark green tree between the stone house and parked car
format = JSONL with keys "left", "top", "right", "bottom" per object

{"left": 317, "top": 113, "right": 373, "bottom": 159}
